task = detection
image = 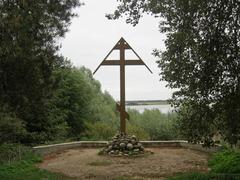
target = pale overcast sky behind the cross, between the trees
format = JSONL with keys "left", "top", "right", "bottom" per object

{"left": 61, "top": 0, "right": 173, "bottom": 100}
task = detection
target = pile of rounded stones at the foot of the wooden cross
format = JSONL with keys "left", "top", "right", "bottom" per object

{"left": 100, "top": 134, "right": 145, "bottom": 156}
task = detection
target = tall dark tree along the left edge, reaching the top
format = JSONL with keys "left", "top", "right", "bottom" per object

{"left": 0, "top": 0, "right": 80, "bottom": 142}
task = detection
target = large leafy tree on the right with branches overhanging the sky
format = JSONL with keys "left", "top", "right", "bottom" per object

{"left": 107, "top": 0, "right": 240, "bottom": 144}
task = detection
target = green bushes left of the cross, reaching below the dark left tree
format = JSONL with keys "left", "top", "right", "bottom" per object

{"left": 0, "top": 57, "right": 119, "bottom": 144}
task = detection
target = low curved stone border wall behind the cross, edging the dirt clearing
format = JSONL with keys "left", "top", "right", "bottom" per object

{"left": 33, "top": 140, "right": 221, "bottom": 155}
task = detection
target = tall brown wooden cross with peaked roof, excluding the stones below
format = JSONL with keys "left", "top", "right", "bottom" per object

{"left": 93, "top": 38, "right": 152, "bottom": 134}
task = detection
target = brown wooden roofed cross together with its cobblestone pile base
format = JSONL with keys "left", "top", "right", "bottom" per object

{"left": 93, "top": 38, "right": 152, "bottom": 155}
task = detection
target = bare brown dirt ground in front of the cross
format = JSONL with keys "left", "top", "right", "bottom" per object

{"left": 39, "top": 148, "right": 209, "bottom": 180}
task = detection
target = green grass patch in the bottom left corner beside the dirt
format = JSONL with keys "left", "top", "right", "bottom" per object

{"left": 0, "top": 144, "right": 70, "bottom": 180}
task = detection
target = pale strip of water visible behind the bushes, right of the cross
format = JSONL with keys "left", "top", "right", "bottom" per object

{"left": 126, "top": 104, "right": 173, "bottom": 113}
